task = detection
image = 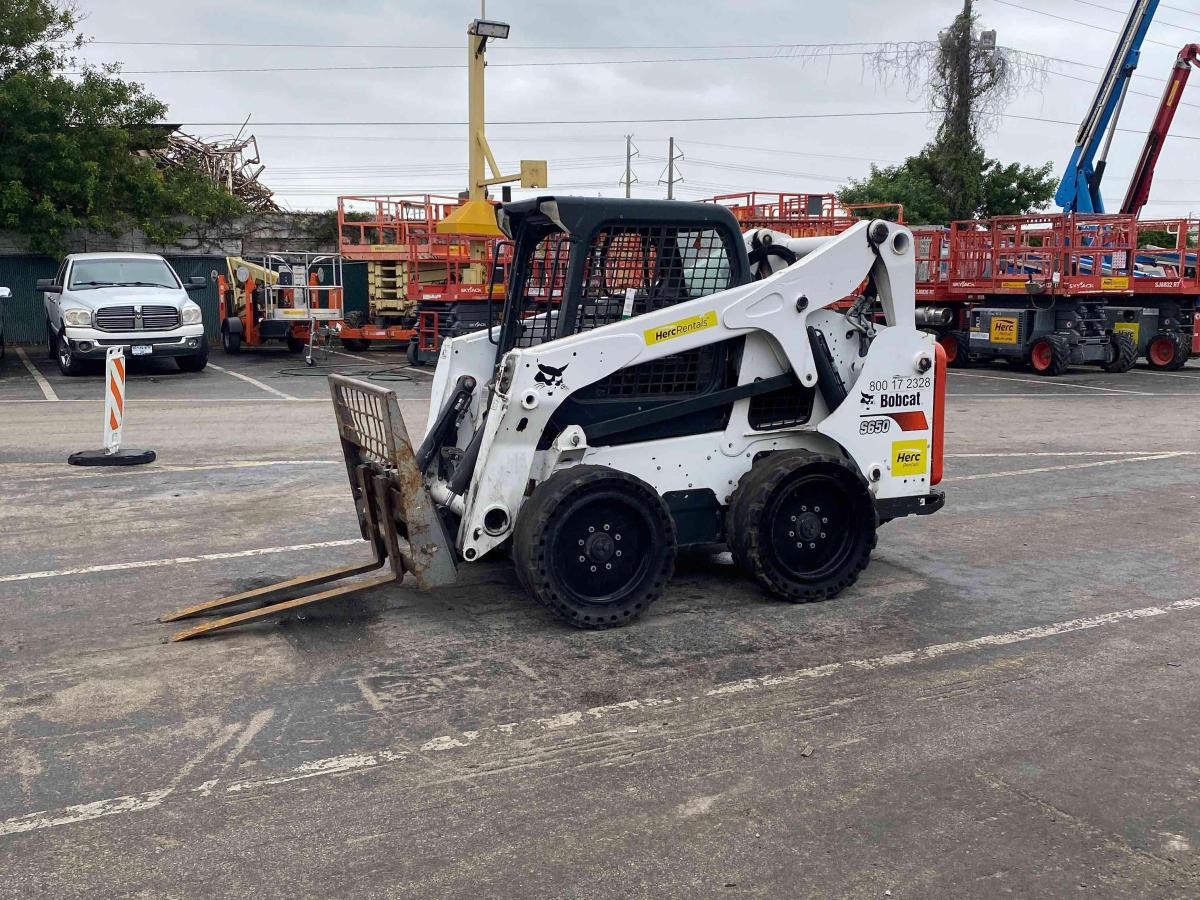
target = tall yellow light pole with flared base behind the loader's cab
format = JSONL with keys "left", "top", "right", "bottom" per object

{"left": 438, "top": 19, "right": 547, "bottom": 250}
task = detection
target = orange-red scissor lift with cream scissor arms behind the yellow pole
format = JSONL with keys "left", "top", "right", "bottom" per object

{"left": 337, "top": 194, "right": 506, "bottom": 362}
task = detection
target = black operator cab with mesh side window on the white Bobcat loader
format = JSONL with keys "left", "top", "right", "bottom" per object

{"left": 497, "top": 197, "right": 752, "bottom": 445}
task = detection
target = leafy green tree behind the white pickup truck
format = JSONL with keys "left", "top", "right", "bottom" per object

{"left": 0, "top": 0, "right": 244, "bottom": 254}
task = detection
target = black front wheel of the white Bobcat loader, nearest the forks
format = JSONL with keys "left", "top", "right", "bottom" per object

{"left": 512, "top": 466, "right": 676, "bottom": 629}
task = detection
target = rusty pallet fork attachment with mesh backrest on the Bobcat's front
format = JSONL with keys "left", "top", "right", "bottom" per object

{"left": 160, "top": 376, "right": 455, "bottom": 641}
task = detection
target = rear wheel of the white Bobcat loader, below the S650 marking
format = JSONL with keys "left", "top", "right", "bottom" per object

{"left": 726, "top": 450, "right": 878, "bottom": 604}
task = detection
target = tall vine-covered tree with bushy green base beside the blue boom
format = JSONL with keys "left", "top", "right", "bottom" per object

{"left": 838, "top": 0, "right": 1057, "bottom": 224}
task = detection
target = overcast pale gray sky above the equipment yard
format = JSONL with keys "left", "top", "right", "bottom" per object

{"left": 78, "top": 0, "right": 1200, "bottom": 216}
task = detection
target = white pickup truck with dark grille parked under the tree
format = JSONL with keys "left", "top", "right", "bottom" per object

{"left": 37, "top": 253, "right": 209, "bottom": 376}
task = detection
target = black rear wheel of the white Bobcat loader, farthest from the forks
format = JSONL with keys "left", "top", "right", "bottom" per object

{"left": 726, "top": 450, "right": 877, "bottom": 602}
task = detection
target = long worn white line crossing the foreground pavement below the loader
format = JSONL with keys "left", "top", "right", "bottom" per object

{"left": 0, "top": 598, "right": 1200, "bottom": 836}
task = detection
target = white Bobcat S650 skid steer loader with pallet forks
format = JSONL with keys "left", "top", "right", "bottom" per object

{"left": 168, "top": 197, "right": 944, "bottom": 640}
